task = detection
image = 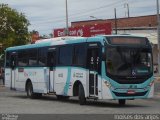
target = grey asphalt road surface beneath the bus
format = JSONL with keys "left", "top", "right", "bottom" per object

{"left": 0, "top": 87, "right": 160, "bottom": 114}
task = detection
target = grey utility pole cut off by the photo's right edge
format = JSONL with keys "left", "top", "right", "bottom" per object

{"left": 156, "top": 0, "right": 160, "bottom": 75}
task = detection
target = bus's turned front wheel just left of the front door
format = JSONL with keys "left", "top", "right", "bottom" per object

{"left": 78, "top": 84, "right": 86, "bottom": 105}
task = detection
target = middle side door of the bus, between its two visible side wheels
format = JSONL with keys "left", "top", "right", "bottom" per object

{"left": 47, "top": 50, "right": 56, "bottom": 92}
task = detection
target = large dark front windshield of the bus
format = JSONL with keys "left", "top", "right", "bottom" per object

{"left": 106, "top": 46, "right": 152, "bottom": 77}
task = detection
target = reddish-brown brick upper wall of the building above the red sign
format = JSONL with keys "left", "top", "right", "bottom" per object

{"left": 71, "top": 15, "right": 157, "bottom": 29}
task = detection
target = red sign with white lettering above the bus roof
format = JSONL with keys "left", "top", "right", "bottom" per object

{"left": 54, "top": 23, "right": 112, "bottom": 37}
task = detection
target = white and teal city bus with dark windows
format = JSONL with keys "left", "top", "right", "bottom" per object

{"left": 5, "top": 35, "right": 154, "bottom": 105}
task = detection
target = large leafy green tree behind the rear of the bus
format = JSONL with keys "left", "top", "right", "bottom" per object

{"left": 0, "top": 4, "right": 30, "bottom": 50}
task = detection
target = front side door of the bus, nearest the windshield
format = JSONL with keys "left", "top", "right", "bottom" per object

{"left": 87, "top": 43, "right": 101, "bottom": 97}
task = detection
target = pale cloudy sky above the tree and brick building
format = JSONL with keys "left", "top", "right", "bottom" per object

{"left": 0, "top": 0, "right": 157, "bottom": 35}
